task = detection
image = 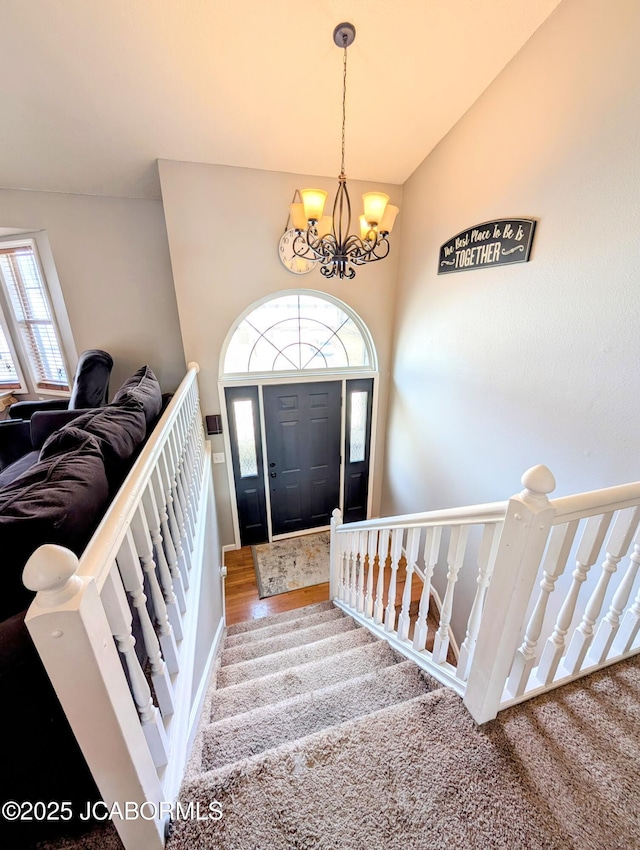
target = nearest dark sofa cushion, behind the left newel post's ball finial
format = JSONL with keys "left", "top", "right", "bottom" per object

{"left": 0, "top": 432, "right": 109, "bottom": 620}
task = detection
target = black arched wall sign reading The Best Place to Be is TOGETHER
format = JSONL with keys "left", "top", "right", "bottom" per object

{"left": 438, "top": 218, "right": 536, "bottom": 274}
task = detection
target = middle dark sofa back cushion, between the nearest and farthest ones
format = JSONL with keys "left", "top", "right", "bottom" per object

{"left": 40, "top": 398, "right": 147, "bottom": 493}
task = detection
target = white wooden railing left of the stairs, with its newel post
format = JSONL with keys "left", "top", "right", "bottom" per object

{"left": 24, "top": 364, "right": 224, "bottom": 850}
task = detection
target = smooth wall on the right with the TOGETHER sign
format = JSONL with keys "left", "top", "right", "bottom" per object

{"left": 383, "top": 0, "right": 640, "bottom": 632}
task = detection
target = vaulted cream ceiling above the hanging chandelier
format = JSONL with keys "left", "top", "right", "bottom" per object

{"left": 0, "top": 0, "right": 560, "bottom": 198}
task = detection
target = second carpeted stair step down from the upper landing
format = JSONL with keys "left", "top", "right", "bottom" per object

{"left": 210, "top": 640, "right": 402, "bottom": 720}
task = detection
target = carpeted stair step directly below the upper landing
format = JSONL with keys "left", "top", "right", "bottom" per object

{"left": 202, "top": 661, "right": 440, "bottom": 771}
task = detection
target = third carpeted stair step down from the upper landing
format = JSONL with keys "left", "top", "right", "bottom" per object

{"left": 217, "top": 622, "right": 377, "bottom": 688}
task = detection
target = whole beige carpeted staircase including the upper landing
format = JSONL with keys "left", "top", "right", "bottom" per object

{"left": 167, "top": 603, "right": 640, "bottom": 850}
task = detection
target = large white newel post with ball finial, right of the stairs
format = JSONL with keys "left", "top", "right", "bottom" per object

{"left": 464, "top": 466, "right": 556, "bottom": 723}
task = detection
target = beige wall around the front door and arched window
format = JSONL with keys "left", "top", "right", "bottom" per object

{"left": 159, "top": 160, "right": 402, "bottom": 544}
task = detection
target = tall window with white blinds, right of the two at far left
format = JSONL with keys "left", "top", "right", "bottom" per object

{"left": 0, "top": 242, "right": 69, "bottom": 392}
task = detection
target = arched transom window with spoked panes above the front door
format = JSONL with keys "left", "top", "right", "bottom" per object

{"left": 223, "top": 292, "right": 376, "bottom": 375}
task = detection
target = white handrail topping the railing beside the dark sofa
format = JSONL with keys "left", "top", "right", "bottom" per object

{"left": 78, "top": 362, "right": 200, "bottom": 590}
